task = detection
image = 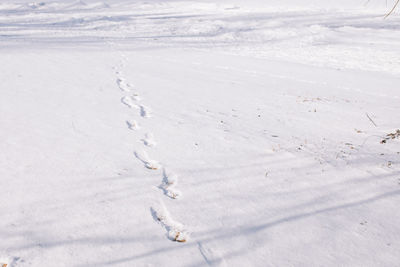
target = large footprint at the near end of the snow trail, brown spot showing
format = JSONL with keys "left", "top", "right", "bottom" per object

{"left": 150, "top": 202, "right": 189, "bottom": 243}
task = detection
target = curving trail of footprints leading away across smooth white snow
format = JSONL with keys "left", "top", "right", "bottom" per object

{"left": 115, "top": 54, "right": 189, "bottom": 242}
